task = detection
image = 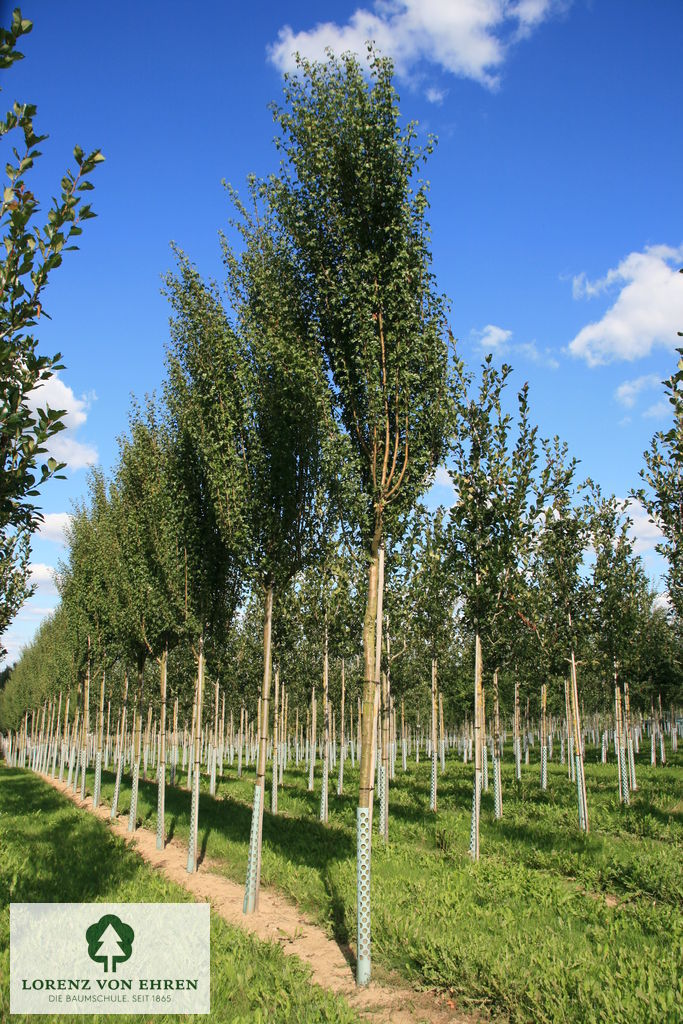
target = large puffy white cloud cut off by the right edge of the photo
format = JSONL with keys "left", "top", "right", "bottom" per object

{"left": 569, "top": 245, "right": 683, "bottom": 367}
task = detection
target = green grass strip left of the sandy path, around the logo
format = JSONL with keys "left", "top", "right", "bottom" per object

{"left": 0, "top": 765, "right": 358, "bottom": 1024}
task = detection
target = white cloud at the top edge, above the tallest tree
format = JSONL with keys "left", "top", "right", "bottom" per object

{"left": 267, "top": 0, "right": 559, "bottom": 88}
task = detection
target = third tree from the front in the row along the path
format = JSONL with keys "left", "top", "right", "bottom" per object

{"left": 165, "top": 264, "right": 248, "bottom": 872}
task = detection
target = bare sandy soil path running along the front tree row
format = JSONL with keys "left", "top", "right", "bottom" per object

{"left": 42, "top": 775, "right": 480, "bottom": 1024}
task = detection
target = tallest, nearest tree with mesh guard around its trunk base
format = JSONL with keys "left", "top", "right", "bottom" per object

{"left": 270, "top": 50, "right": 449, "bottom": 984}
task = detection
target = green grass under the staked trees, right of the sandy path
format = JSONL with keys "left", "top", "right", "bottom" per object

{"left": 89, "top": 749, "right": 683, "bottom": 1024}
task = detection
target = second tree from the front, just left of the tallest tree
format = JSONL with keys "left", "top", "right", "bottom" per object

{"left": 223, "top": 186, "right": 336, "bottom": 913}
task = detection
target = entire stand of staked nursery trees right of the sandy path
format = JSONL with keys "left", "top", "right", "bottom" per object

{"left": 0, "top": 51, "right": 683, "bottom": 984}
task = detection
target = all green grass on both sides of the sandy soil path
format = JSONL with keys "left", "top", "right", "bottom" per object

{"left": 0, "top": 733, "right": 683, "bottom": 1022}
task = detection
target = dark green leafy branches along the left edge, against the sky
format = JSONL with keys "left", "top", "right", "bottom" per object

{"left": 0, "top": 7, "right": 104, "bottom": 636}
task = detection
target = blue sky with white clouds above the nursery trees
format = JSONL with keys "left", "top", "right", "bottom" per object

{"left": 0, "top": 0, "right": 683, "bottom": 660}
